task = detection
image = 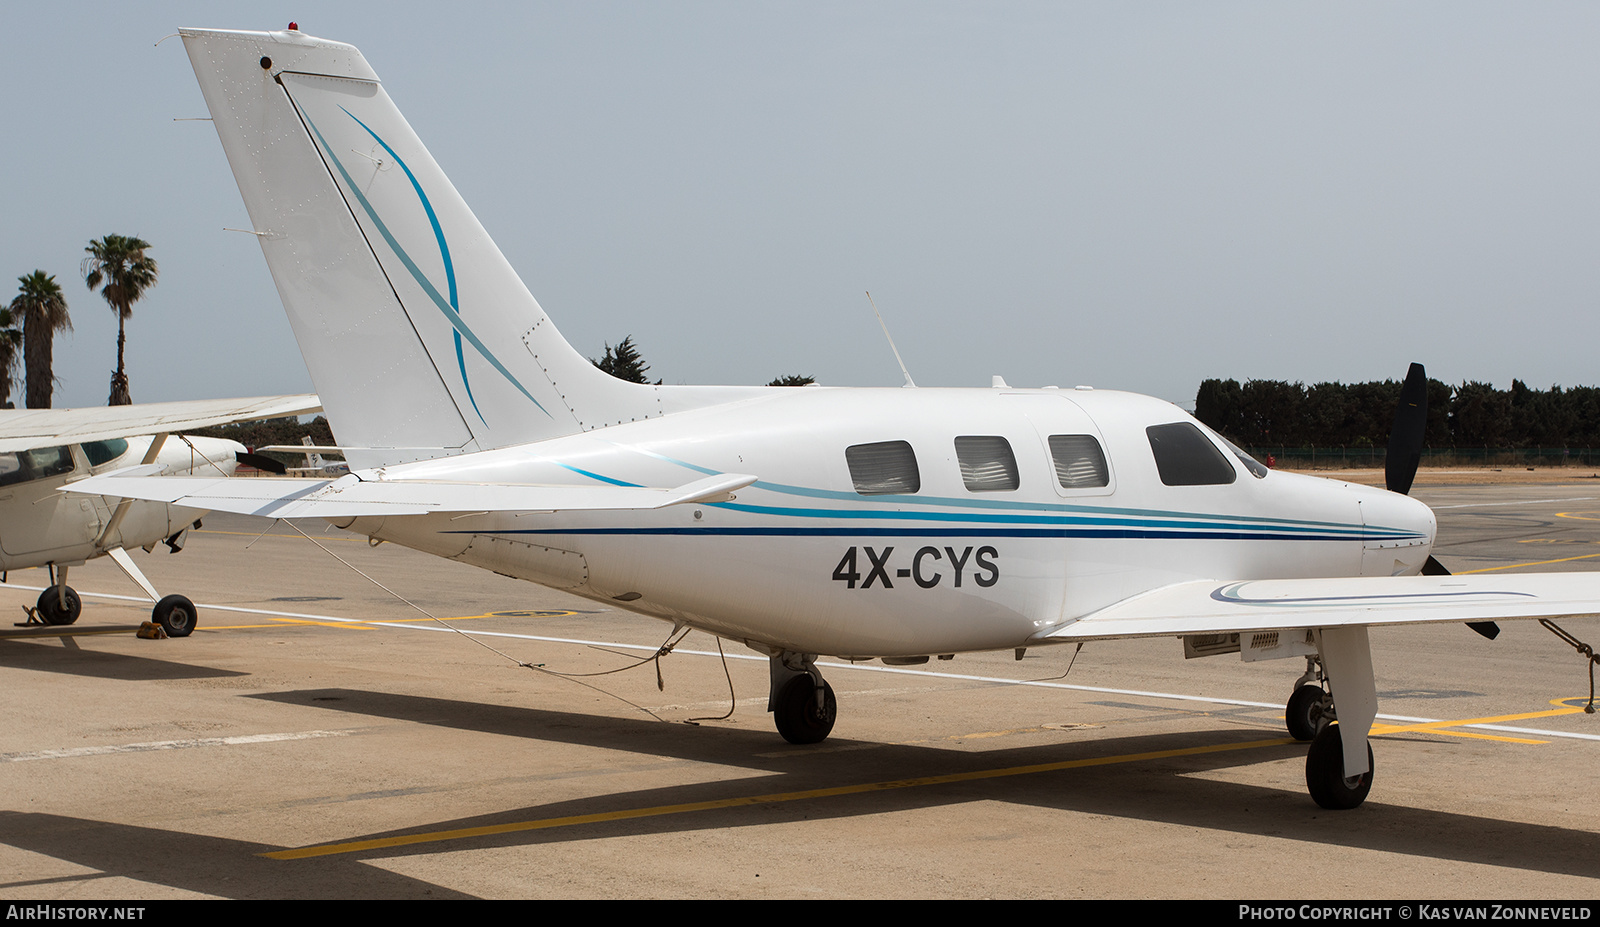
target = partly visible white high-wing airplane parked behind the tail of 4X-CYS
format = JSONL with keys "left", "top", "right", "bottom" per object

{"left": 0, "top": 395, "right": 320, "bottom": 637}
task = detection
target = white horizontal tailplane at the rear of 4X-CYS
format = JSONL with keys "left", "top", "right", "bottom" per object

{"left": 64, "top": 468, "right": 755, "bottom": 519}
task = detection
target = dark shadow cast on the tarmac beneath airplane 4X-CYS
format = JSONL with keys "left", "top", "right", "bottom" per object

{"left": 233, "top": 688, "right": 1600, "bottom": 877}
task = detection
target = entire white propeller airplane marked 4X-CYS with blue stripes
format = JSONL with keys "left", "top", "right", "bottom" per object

{"left": 78, "top": 29, "right": 1600, "bottom": 807}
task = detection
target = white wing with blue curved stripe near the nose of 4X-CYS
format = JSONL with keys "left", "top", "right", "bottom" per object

{"left": 1034, "top": 573, "right": 1600, "bottom": 642}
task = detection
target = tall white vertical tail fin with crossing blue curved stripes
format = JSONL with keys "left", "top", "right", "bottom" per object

{"left": 181, "top": 29, "right": 661, "bottom": 468}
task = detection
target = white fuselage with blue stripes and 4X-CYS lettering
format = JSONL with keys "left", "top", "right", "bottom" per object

{"left": 336, "top": 387, "right": 1435, "bottom": 658}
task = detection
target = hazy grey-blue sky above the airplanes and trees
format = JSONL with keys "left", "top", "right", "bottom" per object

{"left": 0, "top": 0, "right": 1600, "bottom": 407}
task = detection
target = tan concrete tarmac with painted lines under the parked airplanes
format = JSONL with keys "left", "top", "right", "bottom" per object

{"left": 0, "top": 474, "right": 1600, "bottom": 901}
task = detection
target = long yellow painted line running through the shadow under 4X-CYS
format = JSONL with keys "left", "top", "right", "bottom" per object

{"left": 261, "top": 736, "right": 1294, "bottom": 860}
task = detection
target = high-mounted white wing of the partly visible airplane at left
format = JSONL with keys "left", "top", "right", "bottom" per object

{"left": 0, "top": 394, "right": 322, "bottom": 453}
